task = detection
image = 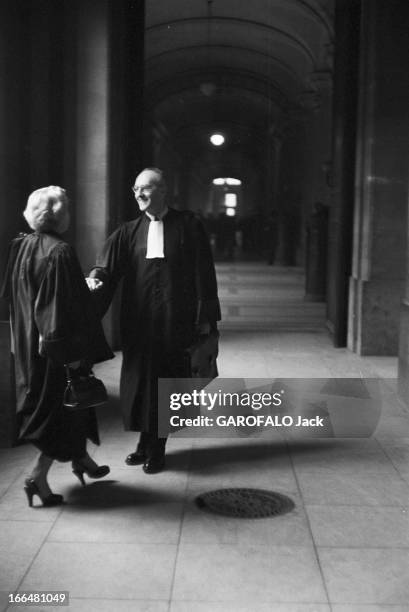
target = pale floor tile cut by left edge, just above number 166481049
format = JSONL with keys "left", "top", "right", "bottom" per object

{"left": 0, "top": 521, "right": 50, "bottom": 591}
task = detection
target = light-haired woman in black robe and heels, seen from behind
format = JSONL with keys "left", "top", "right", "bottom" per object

{"left": 2, "top": 186, "right": 113, "bottom": 506}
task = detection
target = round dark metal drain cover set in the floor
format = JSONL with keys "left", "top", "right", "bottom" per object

{"left": 196, "top": 489, "right": 294, "bottom": 518}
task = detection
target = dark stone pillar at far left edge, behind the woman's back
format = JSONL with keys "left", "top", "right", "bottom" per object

{"left": 0, "top": 0, "right": 30, "bottom": 447}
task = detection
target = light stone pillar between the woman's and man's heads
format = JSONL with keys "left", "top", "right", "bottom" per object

{"left": 75, "top": 0, "right": 109, "bottom": 270}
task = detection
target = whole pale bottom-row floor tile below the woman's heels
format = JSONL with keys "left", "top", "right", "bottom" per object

{"left": 21, "top": 542, "right": 176, "bottom": 600}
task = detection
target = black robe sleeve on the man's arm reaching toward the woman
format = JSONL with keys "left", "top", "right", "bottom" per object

{"left": 89, "top": 225, "right": 129, "bottom": 317}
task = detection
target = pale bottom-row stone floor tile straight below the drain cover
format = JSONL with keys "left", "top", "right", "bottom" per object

{"left": 173, "top": 544, "right": 327, "bottom": 608}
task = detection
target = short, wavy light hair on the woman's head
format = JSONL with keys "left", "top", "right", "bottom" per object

{"left": 23, "top": 185, "right": 69, "bottom": 233}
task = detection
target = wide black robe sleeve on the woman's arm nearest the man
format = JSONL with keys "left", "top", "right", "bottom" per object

{"left": 34, "top": 243, "right": 113, "bottom": 364}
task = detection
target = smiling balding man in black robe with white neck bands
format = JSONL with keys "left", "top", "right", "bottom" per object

{"left": 88, "top": 168, "right": 220, "bottom": 474}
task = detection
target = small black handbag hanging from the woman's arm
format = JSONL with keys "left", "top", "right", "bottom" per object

{"left": 63, "top": 366, "right": 108, "bottom": 411}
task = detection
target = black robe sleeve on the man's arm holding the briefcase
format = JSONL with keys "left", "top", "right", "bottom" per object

{"left": 193, "top": 216, "right": 221, "bottom": 327}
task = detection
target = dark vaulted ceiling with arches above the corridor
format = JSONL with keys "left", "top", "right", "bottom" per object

{"left": 145, "top": 0, "right": 333, "bottom": 175}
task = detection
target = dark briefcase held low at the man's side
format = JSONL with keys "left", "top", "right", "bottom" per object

{"left": 186, "top": 331, "right": 219, "bottom": 380}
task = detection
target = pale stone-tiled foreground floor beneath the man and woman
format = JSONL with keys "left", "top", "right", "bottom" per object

{"left": 0, "top": 331, "right": 409, "bottom": 612}
